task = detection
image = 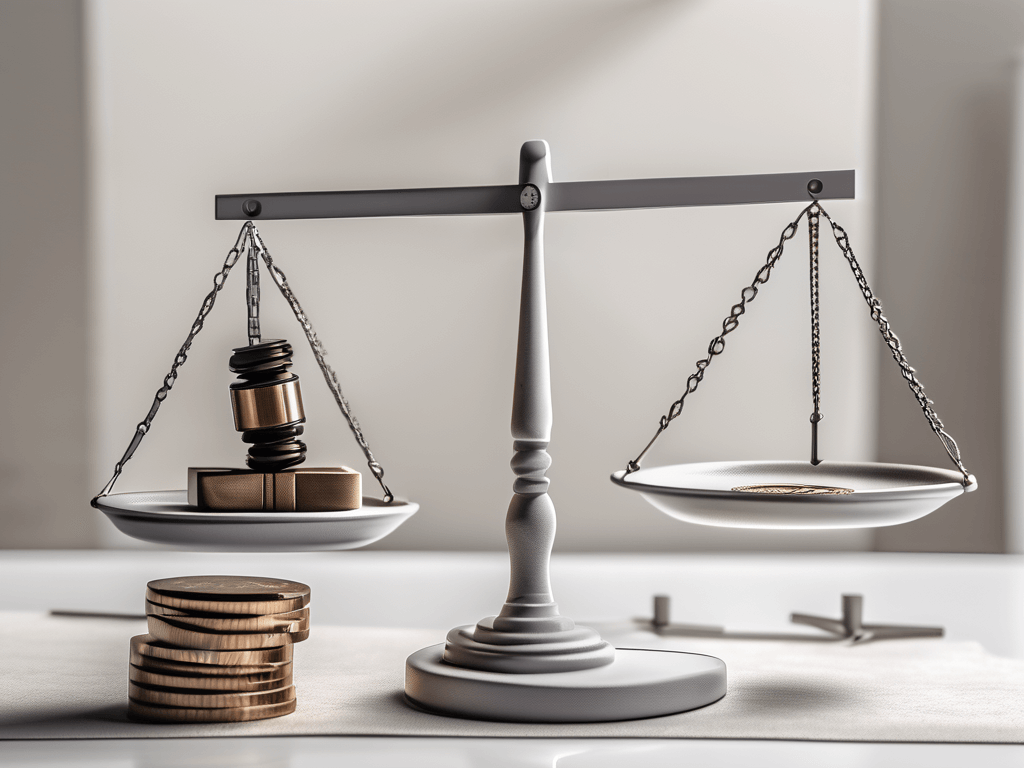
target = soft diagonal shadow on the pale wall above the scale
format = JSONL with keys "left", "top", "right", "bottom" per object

{"left": 335, "top": 0, "right": 693, "bottom": 140}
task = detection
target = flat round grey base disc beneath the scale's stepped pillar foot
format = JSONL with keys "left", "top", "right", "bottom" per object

{"left": 406, "top": 643, "right": 726, "bottom": 723}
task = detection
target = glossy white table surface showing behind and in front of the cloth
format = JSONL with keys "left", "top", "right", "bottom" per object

{"left": 0, "top": 551, "right": 1024, "bottom": 768}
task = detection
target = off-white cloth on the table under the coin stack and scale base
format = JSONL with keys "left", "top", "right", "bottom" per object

{"left": 0, "top": 612, "right": 1024, "bottom": 742}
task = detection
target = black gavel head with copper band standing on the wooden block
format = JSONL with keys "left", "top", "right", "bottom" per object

{"left": 228, "top": 339, "right": 306, "bottom": 472}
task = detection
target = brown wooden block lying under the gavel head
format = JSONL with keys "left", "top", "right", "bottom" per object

{"left": 188, "top": 467, "right": 362, "bottom": 512}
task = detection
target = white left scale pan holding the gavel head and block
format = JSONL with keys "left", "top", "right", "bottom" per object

{"left": 95, "top": 490, "right": 420, "bottom": 552}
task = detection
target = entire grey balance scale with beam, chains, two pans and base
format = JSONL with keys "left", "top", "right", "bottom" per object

{"left": 93, "top": 141, "right": 977, "bottom": 723}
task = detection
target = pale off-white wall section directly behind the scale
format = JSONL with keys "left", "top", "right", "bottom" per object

{"left": 86, "top": 0, "right": 878, "bottom": 550}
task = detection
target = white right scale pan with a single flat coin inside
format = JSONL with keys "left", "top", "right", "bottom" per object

{"left": 611, "top": 461, "right": 977, "bottom": 528}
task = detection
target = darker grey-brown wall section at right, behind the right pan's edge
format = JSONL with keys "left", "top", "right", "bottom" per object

{"left": 876, "top": 0, "right": 1024, "bottom": 552}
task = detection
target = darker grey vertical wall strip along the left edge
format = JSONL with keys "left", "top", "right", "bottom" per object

{"left": 0, "top": 0, "right": 97, "bottom": 548}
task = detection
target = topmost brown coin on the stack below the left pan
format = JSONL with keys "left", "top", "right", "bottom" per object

{"left": 146, "top": 575, "right": 309, "bottom": 613}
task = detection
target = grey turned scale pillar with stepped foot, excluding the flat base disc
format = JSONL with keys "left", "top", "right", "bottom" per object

{"left": 444, "top": 141, "right": 615, "bottom": 674}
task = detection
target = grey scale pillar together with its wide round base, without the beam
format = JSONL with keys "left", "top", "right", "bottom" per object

{"left": 406, "top": 141, "right": 726, "bottom": 723}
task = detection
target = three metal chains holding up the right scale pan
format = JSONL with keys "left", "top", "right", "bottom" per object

{"left": 626, "top": 201, "right": 974, "bottom": 485}
